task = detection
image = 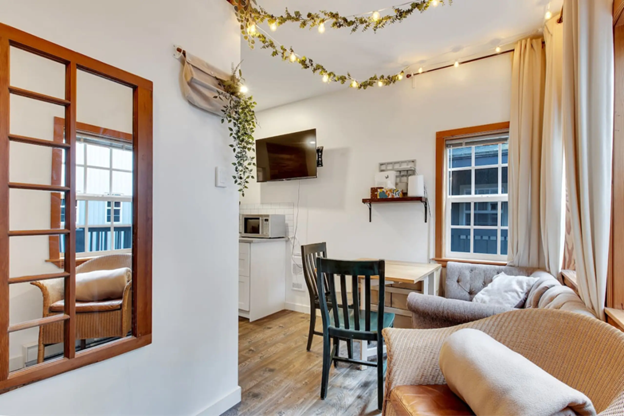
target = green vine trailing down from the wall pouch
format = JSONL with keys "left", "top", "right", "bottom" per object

{"left": 215, "top": 65, "right": 258, "bottom": 196}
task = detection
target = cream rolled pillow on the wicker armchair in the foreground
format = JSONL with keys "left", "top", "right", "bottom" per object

{"left": 440, "top": 329, "right": 596, "bottom": 416}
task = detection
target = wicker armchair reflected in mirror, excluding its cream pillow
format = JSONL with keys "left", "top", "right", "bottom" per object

{"left": 32, "top": 254, "right": 132, "bottom": 363}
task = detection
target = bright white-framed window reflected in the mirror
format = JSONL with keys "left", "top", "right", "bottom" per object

{"left": 61, "top": 134, "right": 133, "bottom": 257}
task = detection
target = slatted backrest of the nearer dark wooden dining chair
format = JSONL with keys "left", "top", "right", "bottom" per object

{"left": 316, "top": 257, "right": 386, "bottom": 334}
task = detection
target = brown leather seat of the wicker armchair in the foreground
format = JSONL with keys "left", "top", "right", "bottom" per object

{"left": 390, "top": 384, "right": 474, "bottom": 416}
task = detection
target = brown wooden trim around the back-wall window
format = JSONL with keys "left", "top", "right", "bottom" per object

{"left": 435, "top": 121, "right": 509, "bottom": 263}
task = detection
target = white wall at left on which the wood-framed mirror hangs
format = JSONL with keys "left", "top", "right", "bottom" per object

{"left": 0, "top": 0, "right": 240, "bottom": 415}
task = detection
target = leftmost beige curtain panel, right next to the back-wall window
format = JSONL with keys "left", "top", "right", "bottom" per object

{"left": 508, "top": 39, "right": 545, "bottom": 267}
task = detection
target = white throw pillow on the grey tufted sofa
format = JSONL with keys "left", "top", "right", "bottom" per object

{"left": 472, "top": 273, "right": 538, "bottom": 308}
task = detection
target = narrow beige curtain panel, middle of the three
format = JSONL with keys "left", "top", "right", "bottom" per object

{"left": 540, "top": 16, "right": 565, "bottom": 277}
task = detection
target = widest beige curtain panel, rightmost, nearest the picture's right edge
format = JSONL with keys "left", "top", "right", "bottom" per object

{"left": 563, "top": 0, "right": 621, "bottom": 319}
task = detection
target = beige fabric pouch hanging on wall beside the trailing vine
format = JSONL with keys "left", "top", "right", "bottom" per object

{"left": 180, "top": 52, "right": 230, "bottom": 116}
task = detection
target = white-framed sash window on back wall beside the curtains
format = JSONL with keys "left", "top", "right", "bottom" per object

{"left": 445, "top": 134, "right": 509, "bottom": 261}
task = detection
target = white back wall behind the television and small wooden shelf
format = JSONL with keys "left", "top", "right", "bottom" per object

{"left": 243, "top": 55, "right": 511, "bottom": 307}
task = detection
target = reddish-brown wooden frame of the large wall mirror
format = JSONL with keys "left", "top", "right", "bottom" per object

{"left": 0, "top": 23, "right": 153, "bottom": 393}
